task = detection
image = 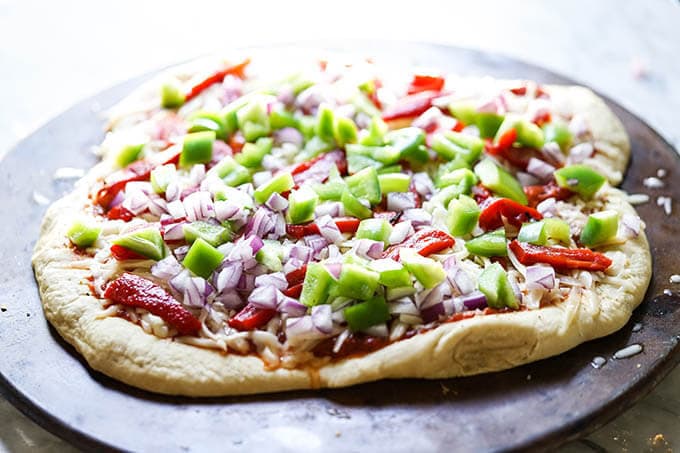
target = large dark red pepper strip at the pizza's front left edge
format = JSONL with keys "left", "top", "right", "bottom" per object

{"left": 104, "top": 273, "right": 201, "bottom": 335}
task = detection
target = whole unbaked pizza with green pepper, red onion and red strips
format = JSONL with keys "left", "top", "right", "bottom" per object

{"left": 33, "top": 51, "right": 651, "bottom": 396}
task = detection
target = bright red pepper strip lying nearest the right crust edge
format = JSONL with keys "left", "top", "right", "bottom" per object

{"left": 510, "top": 239, "right": 612, "bottom": 271}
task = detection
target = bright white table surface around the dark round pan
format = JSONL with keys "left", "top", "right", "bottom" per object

{"left": 0, "top": 0, "right": 680, "bottom": 453}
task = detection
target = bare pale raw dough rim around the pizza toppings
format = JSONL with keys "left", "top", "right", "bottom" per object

{"left": 33, "top": 53, "right": 651, "bottom": 396}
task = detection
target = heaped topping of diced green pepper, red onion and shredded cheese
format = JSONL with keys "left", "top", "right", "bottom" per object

{"left": 83, "top": 57, "right": 642, "bottom": 357}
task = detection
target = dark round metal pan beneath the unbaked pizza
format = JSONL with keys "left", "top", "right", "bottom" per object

{"left": 0, "top": 43, "right": 680, "bottom": 452}
